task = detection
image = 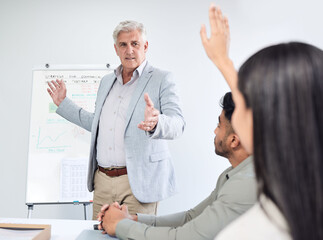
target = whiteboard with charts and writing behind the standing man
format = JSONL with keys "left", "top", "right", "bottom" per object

{"left": 26, "top": 65, "right": 113, "bottom": 203}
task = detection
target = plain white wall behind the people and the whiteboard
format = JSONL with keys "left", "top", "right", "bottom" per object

{"left": 0, "top": 0, "right": 323, "bottom": 219}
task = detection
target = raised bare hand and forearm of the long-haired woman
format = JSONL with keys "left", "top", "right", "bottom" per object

{"left": 200, "top": 4, "right": 238, "bottom": 91}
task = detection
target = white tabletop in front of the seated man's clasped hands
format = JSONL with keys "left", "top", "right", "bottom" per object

{"left": 0, "top": 218, "right": 117, "bottom": 240}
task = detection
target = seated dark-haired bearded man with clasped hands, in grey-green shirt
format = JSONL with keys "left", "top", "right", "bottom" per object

{"left": 98, "top": 93, "right": 256, "bottom": 240}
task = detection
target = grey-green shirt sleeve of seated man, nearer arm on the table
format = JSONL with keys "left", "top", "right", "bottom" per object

{"left": 116, "top": 174, "right": 256, "bottom": 240}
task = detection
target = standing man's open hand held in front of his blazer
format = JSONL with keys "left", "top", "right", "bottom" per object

{"left": 138, "top": 93, "right": 159, "bottom": 131}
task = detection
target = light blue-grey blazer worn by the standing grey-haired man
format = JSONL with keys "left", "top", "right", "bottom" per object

{"left": 56, "top": 63, "right": 185, "bottom": 202}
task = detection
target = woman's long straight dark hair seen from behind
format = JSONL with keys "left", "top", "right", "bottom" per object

{"left": 238, "top": 42, "right": 323, "bottom": 240}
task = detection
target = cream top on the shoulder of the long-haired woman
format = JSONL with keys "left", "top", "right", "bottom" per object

{"left": 215, "top": 195, "right": 292, "bottom": 240}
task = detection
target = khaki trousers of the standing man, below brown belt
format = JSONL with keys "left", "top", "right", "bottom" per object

{"left": 93, "top": 170, "right": 158, "bottom": 220}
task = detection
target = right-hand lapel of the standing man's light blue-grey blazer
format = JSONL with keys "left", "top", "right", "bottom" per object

{"left": 125, "top": 63, "right": 153, "bottom": 129}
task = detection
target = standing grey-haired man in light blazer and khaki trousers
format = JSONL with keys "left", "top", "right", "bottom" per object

{"left": 48, "top": 21, "right": 185, "bottom": 219}
